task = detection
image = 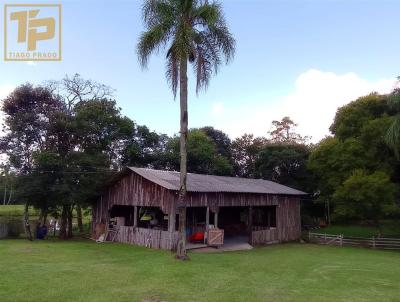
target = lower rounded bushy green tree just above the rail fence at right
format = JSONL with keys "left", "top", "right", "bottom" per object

{"left": 333, "top": 170, "right": 399, "bottom": 226}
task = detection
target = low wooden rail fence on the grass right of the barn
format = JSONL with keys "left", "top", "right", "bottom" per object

{"left": 308, "top": 232, "right": 400, "bottom": 250}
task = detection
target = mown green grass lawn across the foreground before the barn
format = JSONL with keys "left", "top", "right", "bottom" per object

{"left": 0, "top": 240, "right": 400, "bottom": 302}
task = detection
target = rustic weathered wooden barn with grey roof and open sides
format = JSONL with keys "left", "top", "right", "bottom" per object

{"left": 93, "top": 167, "right": 305, "bottom": 250}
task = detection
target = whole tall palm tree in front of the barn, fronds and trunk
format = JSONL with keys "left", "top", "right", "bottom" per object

{"left": 137, "top": 0, "right": 235, "bottom": 259}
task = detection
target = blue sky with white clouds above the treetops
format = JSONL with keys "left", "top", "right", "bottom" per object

{"left": 0, "top": 0, "right": 400, "bottom": 140}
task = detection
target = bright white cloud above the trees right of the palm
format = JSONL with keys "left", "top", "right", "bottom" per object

{"left": 216, "top": 69, "right": 396, "bottom": 142}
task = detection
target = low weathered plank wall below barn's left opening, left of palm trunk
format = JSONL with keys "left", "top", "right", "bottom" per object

{"left": 115, "top": 226, "right": 178, "bottom": 250}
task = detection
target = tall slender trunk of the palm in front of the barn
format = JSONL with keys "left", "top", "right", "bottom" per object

{"left": 176, "top": 58, "right": 188, "bottom": 260}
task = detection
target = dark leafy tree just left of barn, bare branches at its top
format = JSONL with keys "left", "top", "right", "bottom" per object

{"left": 48, "top": 74, "right": 134, "bottom": 238}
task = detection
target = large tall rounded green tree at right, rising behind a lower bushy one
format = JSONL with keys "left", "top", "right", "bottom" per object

{"left": 308, "top": 94, "right": 399, "bottom": 220}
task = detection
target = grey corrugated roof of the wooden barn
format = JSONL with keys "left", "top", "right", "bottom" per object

{"left": 129, "top": 167, "right": 307, "bottom": 195}
